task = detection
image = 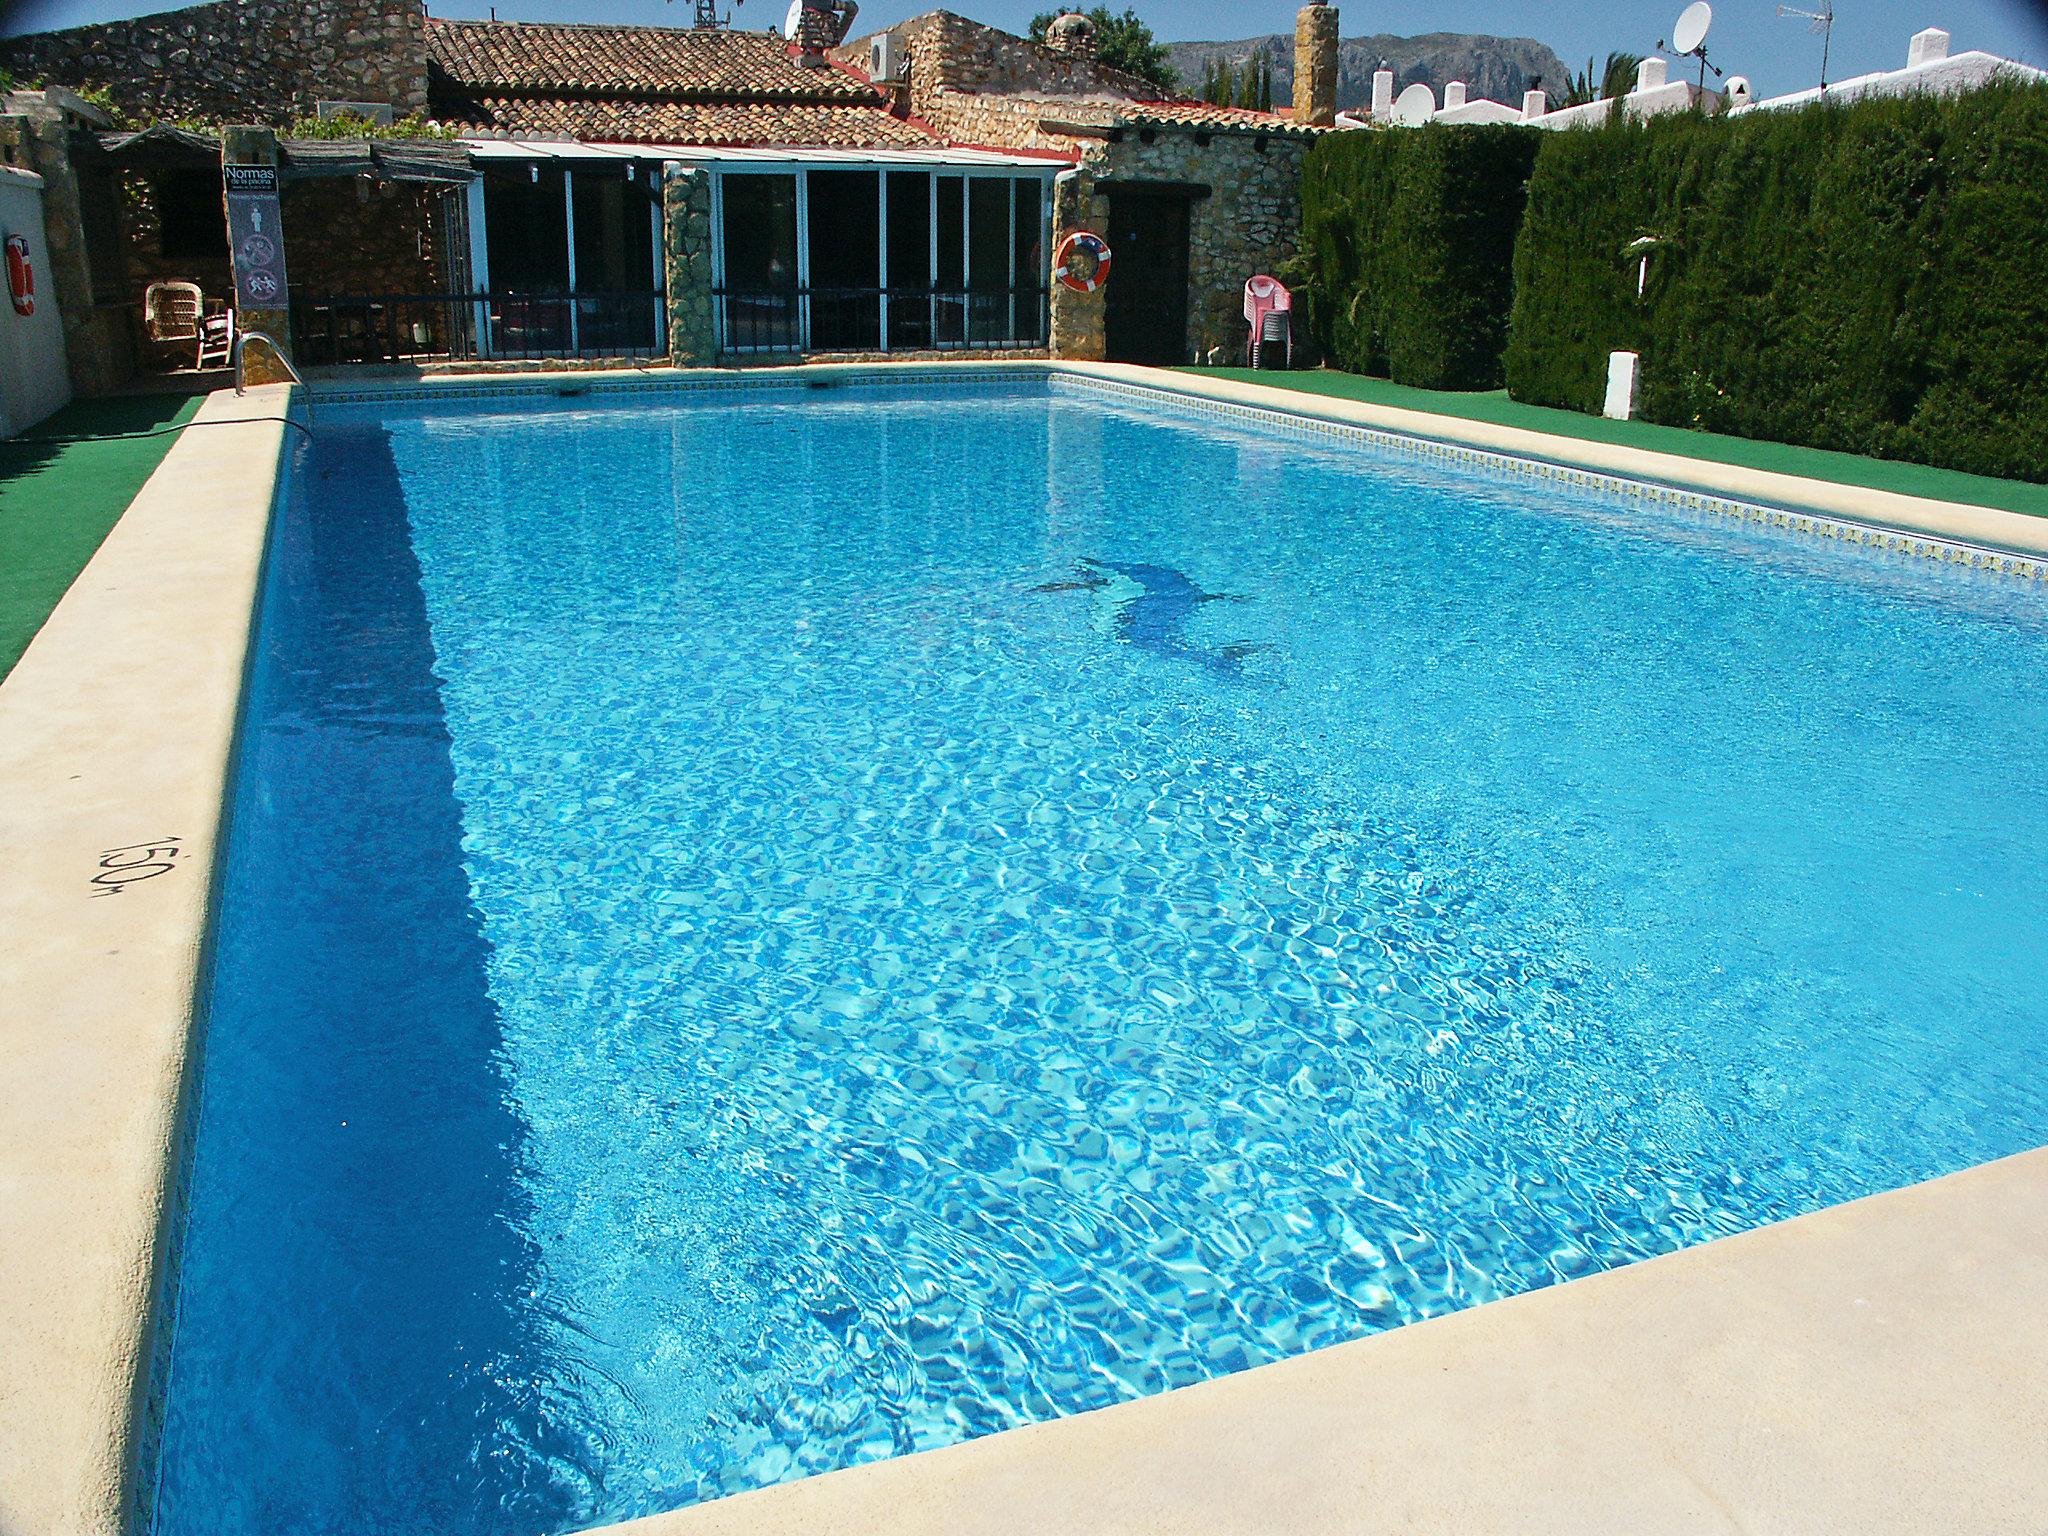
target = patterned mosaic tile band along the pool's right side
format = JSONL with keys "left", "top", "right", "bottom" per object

{"left": 1053, "top": 373, "right": 2048, "bottom": 582}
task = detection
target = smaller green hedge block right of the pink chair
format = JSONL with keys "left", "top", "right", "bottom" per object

{"left": 1294, "top": 123, "right": 1542, "bottom": 389}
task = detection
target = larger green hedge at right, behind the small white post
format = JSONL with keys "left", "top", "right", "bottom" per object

{"left": 1507, "top": 84, "right": 2048, "bottom": 481}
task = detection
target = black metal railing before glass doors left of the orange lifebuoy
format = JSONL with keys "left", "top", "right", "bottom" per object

{"left": 713, "top": 285, "right": 1047, "bottom": 352}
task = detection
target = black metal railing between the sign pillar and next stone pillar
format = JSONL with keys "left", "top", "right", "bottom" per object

{"left": 291, "top": 291, "right": 666, "bottom": 367}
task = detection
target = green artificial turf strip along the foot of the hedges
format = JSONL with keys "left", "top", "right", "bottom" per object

{"left": 1180, "top": 369, "right": 2048, "bottom": 518}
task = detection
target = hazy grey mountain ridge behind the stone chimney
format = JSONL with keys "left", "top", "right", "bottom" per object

{"left": 1167, "top": 33, "right": 1569, "bottom": 111}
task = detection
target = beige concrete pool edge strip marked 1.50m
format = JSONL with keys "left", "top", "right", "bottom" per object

{"left": 0, "top": 387, "right": 291, "bottom": 1536}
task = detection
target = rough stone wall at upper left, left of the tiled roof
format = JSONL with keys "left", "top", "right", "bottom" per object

{"left": 0, "top": 0, "right": 426, "bottom": 127}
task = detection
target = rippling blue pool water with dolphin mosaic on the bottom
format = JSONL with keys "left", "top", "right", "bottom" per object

{"left": 154, "top": 385, "right": 2048, "bottom": 1536}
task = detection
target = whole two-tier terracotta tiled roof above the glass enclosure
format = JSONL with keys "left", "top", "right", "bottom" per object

{"left": 426, "top": 16, "right": 934, "bottom": 150}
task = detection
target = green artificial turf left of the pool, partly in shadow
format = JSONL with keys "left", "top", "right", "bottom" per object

{"left": 0, "top": 395, "right": 203, "bottom": 678}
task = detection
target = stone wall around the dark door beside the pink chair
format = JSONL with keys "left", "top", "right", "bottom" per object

{"left": 1053, "top": 129, "right": 1309, "bottom": 360}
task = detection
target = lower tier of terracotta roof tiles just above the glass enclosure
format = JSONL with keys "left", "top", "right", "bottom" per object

{"left": 442, "top": 96, "right": 934, "bottom": 150}
